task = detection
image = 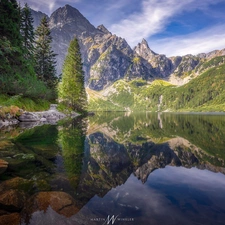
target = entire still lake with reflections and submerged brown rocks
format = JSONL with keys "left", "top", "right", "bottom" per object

{"left": 0, "top": 113, "right": 225, "bottom": 225}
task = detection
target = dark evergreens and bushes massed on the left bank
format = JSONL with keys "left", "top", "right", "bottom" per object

{"left": 0, "top": 0, "right": 58, "bottom": 110}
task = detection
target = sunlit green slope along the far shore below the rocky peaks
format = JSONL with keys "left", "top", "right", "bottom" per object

{"left": 88, "top": 56, "right": 225, "bottom": 111}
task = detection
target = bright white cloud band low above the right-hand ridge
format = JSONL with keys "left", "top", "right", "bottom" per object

{"left": 150, "top": 25, "right": 225, "bottom": 56}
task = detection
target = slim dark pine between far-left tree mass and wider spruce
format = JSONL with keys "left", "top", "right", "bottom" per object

{"left": 20, "top": 3, "right": 34, "bottom": 59}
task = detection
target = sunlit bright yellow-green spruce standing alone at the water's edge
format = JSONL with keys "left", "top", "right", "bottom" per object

{"left": 59, "top": 38, "right": 87, "bottom": 112}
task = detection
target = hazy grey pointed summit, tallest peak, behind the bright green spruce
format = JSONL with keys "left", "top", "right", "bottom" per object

{"left": 49, "top": 5, "right": 101, "bottom": 74}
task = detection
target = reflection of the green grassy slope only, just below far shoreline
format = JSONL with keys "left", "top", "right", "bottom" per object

{"left": 88, "top": 113, "right": 225, "bottom": 167}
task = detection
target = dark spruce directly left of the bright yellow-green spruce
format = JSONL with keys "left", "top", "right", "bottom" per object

{"left": 34, "top": 17, "right": 58, "bottom": 88}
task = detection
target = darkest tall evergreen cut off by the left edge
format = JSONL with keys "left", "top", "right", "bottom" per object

{"left": 0, "top": 0, "right": 25, "bottom": 86}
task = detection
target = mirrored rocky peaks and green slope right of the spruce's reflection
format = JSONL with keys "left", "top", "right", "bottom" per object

{"left": 75, "top": 114, "right": 225, "bottom": 207}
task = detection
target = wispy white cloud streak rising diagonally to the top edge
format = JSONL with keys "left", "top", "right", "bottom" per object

{"left": 109, "top": 0, "right": 222, "bottom": 46}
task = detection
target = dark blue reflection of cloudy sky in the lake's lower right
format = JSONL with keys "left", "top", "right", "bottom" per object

{"left": 76, "top": 166, "right": 225, "bottom": 225}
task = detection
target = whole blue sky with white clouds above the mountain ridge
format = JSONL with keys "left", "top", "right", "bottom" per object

{"left": 20, "top": 0, "right": 225, "bottom": 56}
